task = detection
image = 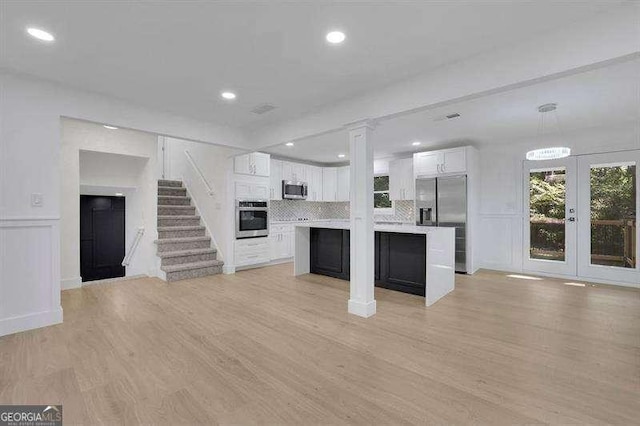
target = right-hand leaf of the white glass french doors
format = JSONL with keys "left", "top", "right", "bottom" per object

{"left": 578, "top": 151, "right": 640, "bottom": 285}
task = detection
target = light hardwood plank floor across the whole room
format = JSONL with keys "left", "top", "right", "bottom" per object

{"left": 0, "top": 264, "right": 640, "bottom": 425}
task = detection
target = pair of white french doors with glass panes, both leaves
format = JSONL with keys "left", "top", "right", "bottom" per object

{"left": 523, "top": 150, "right": 640, "bottom": 286}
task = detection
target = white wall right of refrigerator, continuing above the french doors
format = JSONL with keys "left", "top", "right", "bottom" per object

{"left": 478, "top": 123, "right": 640, "bottom": 272}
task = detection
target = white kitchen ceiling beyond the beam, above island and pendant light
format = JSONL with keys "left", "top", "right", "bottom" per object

{"left": 267, "top": 60, "right": 640, "bottom": 163}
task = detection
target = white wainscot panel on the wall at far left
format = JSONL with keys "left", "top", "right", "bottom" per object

{"left": 0, "top": 217, "right": 62, "bottom": 336}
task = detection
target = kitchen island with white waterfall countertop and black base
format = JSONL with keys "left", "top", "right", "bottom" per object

{"left": 294, "top": 220, "right": 455, "bottom": 306}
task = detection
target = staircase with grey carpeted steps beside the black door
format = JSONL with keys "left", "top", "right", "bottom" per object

{"left": 156, "top": 180, "right": 223, "bottom": 282}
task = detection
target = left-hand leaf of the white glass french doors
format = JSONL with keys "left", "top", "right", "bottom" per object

{"left": 524, "top": 158, "right": 576, "bottom": 275}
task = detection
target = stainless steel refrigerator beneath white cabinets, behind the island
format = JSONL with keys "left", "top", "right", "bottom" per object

{"left": 415, "top": 176, "right": 467, "bottom": 273}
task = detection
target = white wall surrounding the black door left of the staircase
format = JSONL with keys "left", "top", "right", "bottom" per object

{"left": 60, "top": 119, "right": 157, "bottom": 289}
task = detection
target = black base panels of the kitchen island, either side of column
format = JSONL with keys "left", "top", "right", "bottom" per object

{"left": 310, "top": 228, "right": 427, "bottom": 296}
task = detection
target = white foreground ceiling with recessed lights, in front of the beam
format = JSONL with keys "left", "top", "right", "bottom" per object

{"left": 0, "top": 0, "right": 624, "bottom": 130}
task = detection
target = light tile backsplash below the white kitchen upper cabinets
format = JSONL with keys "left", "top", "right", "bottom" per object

{"left": 270, "top": 200, "right": 414, "bottom": 222}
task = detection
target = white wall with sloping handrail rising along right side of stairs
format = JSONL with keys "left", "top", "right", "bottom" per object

{"left": 164, "top": 138, "right": 243, "bottom": 260}
